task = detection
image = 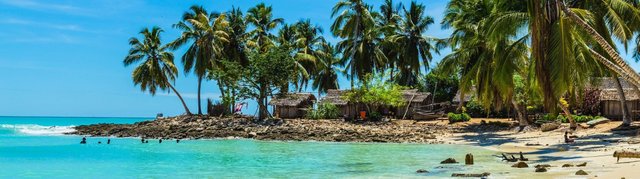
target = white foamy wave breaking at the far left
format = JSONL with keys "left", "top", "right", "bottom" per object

{"left": 0, "top": 124, "right": 75, "bottom": 135}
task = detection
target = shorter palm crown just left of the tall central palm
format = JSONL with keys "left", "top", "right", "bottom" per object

{"left": 311, "top": 43, "right": 342, "bottom": 97}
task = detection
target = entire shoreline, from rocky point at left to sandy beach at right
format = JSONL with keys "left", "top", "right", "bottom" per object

{"left": 71, "top": 116, "right": 640, "bottom": 178}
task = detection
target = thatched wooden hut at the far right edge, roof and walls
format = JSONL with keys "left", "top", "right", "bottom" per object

{"left": 593, "top": 78, "right": 640, "bottom": 119}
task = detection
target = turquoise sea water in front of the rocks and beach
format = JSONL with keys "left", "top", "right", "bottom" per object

{"left": 0, "top": 117, "right": 510, "bottom": 178}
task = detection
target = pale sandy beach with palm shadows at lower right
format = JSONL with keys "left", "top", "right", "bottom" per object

{"left": 444, "top": 119, "right": 640, "bottom": 178}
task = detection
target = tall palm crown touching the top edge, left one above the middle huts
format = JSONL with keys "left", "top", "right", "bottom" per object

{"left": 331, "top": 0, "right": 387, "bottom": 87}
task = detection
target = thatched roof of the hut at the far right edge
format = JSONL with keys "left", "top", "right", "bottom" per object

{"left": 588, "top": 77, "right": 640, "bottom": 101}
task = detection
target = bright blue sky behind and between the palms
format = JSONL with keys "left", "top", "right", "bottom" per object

{"left": 0, "top": 0, "right": 638, "bottom": 117}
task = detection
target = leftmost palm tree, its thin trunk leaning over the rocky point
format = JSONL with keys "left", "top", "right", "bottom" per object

{"left": 124, "top": 27, "right": 191, "bottom": 115}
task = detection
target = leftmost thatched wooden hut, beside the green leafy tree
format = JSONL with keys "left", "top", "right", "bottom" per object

{"left": 269, "top": 93, "right": 316, "bottom": 119}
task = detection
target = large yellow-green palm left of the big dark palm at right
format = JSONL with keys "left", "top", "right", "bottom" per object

{"left": 439, "top": 0, "right": 528, "bottom": 125}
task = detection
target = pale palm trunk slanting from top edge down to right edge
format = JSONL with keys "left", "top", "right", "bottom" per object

{"left": 556, "top": 0, "right": 640, "bottom": 85}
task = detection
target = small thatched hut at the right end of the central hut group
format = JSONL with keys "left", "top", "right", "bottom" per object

{"left": 394, "top": 89, "right": 432, "bottom": 119}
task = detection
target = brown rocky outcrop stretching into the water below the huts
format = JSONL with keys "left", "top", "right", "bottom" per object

{"left": 69, "top": 116, "right": 456, "bottom": 143}
